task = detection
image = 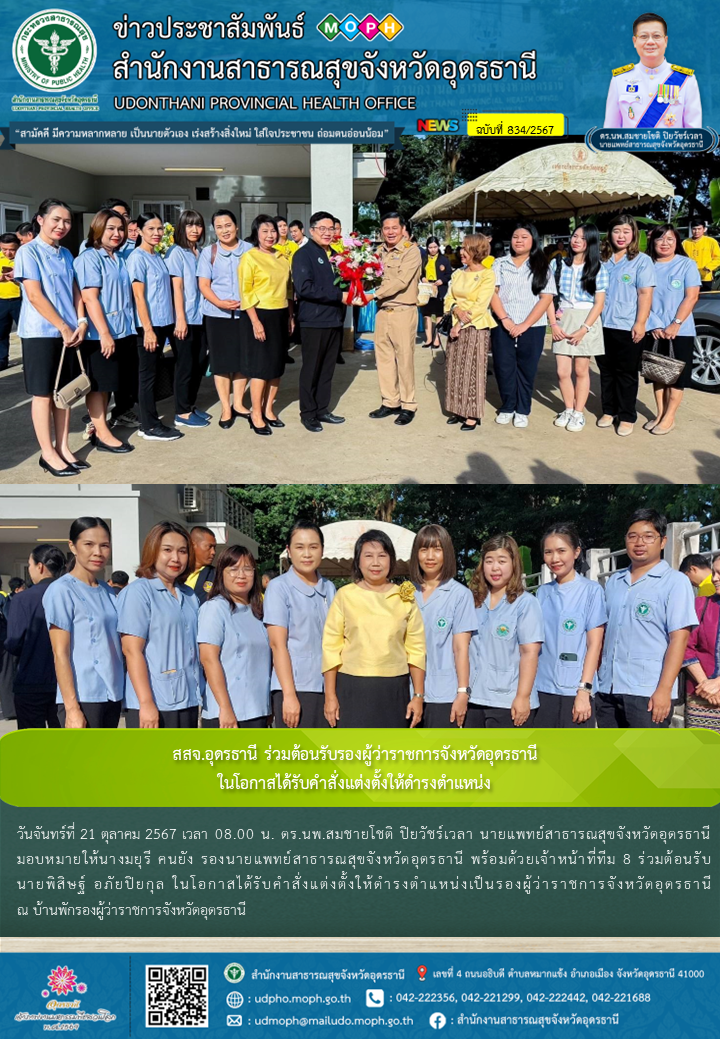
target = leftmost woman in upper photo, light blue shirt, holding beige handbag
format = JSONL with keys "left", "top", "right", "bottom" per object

{"left": 15, "top": 199, "right": 88, "bottom": 476}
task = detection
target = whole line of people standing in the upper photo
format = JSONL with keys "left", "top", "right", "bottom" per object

{"left": 0, "top": 191, "right": 720, "bottom": 478}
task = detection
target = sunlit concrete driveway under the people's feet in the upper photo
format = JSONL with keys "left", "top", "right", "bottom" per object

{"left": 0, "top": 335, "right": 720, "bottom": 484}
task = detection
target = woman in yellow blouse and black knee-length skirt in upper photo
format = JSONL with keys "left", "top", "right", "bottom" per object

{"left": 237, "top": 213, "right": 292, "bottom": 437}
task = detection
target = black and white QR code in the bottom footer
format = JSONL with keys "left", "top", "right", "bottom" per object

{"left": 145, "top": 964, "right": 208, "bottom": 1028}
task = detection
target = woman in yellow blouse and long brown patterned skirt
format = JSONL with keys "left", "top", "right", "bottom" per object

{"left": 445, "top": 235, "right": 497, "bottom": 432}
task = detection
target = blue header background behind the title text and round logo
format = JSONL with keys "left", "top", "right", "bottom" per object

{"left": 0, "top": 0, "right": 720, "bottom": 134}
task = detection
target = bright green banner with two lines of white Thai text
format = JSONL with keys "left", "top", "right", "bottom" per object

{"left": 0, "top": 729, "right": 720, "bottom": 808}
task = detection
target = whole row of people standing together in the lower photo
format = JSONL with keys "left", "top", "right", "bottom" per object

{"left": 0, "top": 508, "right": 720, "bottom": 730}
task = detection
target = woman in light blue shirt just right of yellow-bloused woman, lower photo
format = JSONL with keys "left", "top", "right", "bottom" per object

{"left": 410, "top": 524, "right": 478, "bottom": 729}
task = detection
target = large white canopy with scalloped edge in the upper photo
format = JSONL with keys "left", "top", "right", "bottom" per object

{"left": 412, "top": 145, "right": 675, "bottom": 228}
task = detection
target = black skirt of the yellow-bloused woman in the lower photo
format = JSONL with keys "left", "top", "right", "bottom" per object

{"left": 337, "top": 672, "right": 410, "bottom": 729}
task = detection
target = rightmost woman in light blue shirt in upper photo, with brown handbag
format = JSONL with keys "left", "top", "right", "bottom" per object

{"left": 643, "top": 224, "right": 700, "bottom": 437}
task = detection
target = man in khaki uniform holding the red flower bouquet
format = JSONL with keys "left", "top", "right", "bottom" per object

{"left": 370, "top": 213, "right": 422, "bottom": 426}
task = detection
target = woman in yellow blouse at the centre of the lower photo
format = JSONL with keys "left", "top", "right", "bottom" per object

{"left": 323, "top": 530, "right": 426, "bottom": 729}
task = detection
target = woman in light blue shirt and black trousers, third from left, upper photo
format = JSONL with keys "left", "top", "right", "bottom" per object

{"left": 127, "top": 213, "right": 182, "bottom": 441}
